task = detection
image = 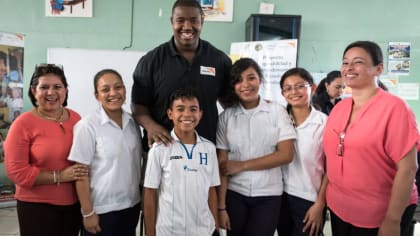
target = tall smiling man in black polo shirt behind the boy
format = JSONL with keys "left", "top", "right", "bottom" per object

{"left": 132, "top": 0, "right": 232, "bottom": 150}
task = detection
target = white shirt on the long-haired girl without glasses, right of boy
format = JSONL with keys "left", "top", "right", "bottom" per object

{"left": 216, "top": 99, "right": 296, "bottom": 197}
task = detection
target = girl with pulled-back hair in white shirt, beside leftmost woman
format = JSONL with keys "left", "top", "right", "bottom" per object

{"left": 69, "top": 69, "right": 142, "bottom": 236}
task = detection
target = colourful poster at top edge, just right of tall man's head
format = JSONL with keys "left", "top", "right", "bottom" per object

{"left": 197, "top": 0, "right": 233, "bottom": 22}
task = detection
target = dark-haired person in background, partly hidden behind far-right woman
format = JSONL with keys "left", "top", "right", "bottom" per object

{"left": 312, "top": 70, "right": 345, "bottom": 115}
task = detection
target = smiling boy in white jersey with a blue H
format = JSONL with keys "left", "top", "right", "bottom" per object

{"left": 144, "top": 88, "right": 220, "bottom": 236}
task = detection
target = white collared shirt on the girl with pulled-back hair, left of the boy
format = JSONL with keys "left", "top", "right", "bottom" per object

{"left": 68, "top": 107, "right": 142, "bottom": 214}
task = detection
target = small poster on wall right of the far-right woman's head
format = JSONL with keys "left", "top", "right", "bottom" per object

{"left": 388, "top": 42, "right": 411, "bottom": 75}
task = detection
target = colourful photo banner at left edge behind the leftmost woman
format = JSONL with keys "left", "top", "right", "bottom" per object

{"left": 0, "top": 32, "right": 24, "bottom": 202}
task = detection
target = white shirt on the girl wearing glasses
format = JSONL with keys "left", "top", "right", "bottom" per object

{"left": 282, "top": 107, "right": 327, "bottom": 202}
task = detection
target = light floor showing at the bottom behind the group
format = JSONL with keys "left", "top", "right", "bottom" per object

{"left": 0, "top": 204, "right": 420, "bottom": 236}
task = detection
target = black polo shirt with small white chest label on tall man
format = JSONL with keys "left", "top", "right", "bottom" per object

{"left": 131, "top": 38, "right": 232, "bottom": 148}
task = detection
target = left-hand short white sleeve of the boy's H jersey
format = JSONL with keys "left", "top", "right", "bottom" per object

{"left": 144, "top": 144, "right": 162, "bottom": 189}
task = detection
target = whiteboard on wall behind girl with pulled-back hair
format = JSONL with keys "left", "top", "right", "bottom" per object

{"left": 47, "top": 48, "right": 145, "bottom": 117}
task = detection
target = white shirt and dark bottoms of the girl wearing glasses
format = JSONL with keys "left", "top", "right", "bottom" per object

{"left": 277, "top": 107, "right": 327, "bottom": 235}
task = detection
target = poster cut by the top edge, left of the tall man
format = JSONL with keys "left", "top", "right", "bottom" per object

{"left": 45, "top": 0, "right": 93, "bottom": 17}
